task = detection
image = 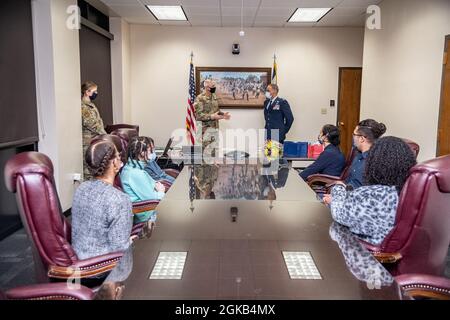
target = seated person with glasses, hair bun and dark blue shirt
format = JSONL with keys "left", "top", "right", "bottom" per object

{"left": 345, "top": 119, "right": 386, "bottom": 189}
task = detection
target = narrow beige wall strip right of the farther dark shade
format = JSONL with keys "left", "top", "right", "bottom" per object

{"left": 109, "top": 18, "right": 131, "bottom": 123}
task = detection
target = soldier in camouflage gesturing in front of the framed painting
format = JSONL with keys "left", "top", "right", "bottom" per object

{"left": 194, "top": 79, "right": 230, "bottom": 157}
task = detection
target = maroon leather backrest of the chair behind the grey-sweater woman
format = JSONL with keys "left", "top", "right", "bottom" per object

{"left": 5, "top": 152, "right": 77, "bottom": 267}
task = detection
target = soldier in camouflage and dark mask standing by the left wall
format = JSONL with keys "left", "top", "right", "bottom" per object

{"left": 81, "top": 81, "right": 106, "bottom": 180}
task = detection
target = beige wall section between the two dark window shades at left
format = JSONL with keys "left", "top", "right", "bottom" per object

{"left": 32, "top": 0, "right": 83, "bottom": 210}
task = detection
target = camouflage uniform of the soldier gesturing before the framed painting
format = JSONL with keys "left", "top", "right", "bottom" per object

{"left": 194, "top": 93, "right": 220, "bottom": 156}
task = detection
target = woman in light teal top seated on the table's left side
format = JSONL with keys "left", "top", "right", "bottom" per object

{"left": 120, "top": 137, "right": 165, "bottom": 223}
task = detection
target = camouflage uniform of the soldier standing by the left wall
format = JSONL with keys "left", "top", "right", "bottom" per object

{"left": 81, "top": 100, "right": 106, "bottom": 180}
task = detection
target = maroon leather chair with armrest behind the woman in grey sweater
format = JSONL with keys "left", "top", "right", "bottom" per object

{"left": 5, "top": 152, "right": 122, "bottom": 281}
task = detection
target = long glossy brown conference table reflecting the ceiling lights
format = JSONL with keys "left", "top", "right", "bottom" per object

{"left": 97, "top": 159, "right": 402, "bottom": 300}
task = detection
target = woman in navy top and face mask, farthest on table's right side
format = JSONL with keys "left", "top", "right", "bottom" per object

{"left": 300, "top": 124, "right": 345, "bottom": 180}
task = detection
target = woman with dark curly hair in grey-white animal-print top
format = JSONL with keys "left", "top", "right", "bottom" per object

{"left": 324, "top": 137, "right": 416, "bottom": 245}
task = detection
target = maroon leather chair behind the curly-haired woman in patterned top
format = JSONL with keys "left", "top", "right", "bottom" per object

{"left": 363, "top": 155, "right": 450, "bottom": 276}
